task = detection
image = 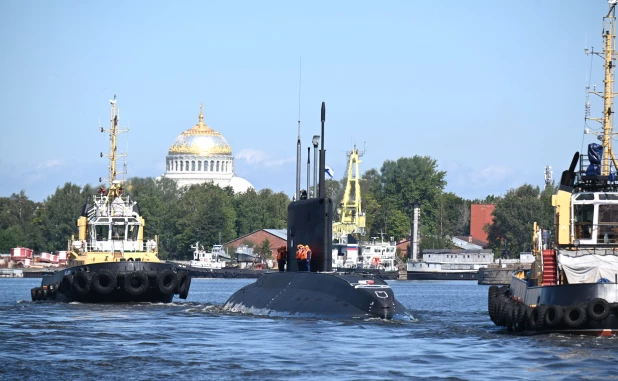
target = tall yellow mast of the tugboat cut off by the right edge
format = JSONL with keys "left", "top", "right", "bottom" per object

{"left": 586, "top": 0, "right": 618, "bottom": 176}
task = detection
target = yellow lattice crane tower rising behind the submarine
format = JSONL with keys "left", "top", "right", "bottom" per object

{"left": 333, "top": 145, "right": 365, "bottom": 240}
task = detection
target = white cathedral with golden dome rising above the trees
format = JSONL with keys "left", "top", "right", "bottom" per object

{"left": 164, "top": 105, "right": 253, "bottom": 193}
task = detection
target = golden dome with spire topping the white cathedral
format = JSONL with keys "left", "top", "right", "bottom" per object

{"left": 169, "top": 105, "right": 232, "bottom": 156}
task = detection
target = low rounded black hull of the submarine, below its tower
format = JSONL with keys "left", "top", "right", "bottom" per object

{"left": 223, "top": 272, "right": 413, "bottom": 320}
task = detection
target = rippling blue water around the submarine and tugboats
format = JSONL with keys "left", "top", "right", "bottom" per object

{"left": 0, "top": 279, "right": 618, "bottom": 380}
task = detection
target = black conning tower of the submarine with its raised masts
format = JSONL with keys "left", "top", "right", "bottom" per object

{"left": 286, "top": 102, "right": 333, "bottom": 272}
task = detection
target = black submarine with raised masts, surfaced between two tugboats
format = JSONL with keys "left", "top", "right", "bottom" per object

{"left": 222, "top": 102, "right": 414, "bottom": 320}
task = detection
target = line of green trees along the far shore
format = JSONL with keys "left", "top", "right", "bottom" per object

{"left": 0, "top": 155, "right": 555, "bottom": 259}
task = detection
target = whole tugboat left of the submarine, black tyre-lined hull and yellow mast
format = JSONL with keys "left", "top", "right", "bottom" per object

{"left": 31, "top": 95, "right": 191, "bottom": 303}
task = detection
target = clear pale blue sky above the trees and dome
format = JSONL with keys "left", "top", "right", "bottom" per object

{"left": 0, "top": 0, "right": 608, "bottom": 201}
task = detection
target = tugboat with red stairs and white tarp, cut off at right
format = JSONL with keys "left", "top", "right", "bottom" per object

{"left": 488, "top": 0, "right": 618, "bottom": 336}
